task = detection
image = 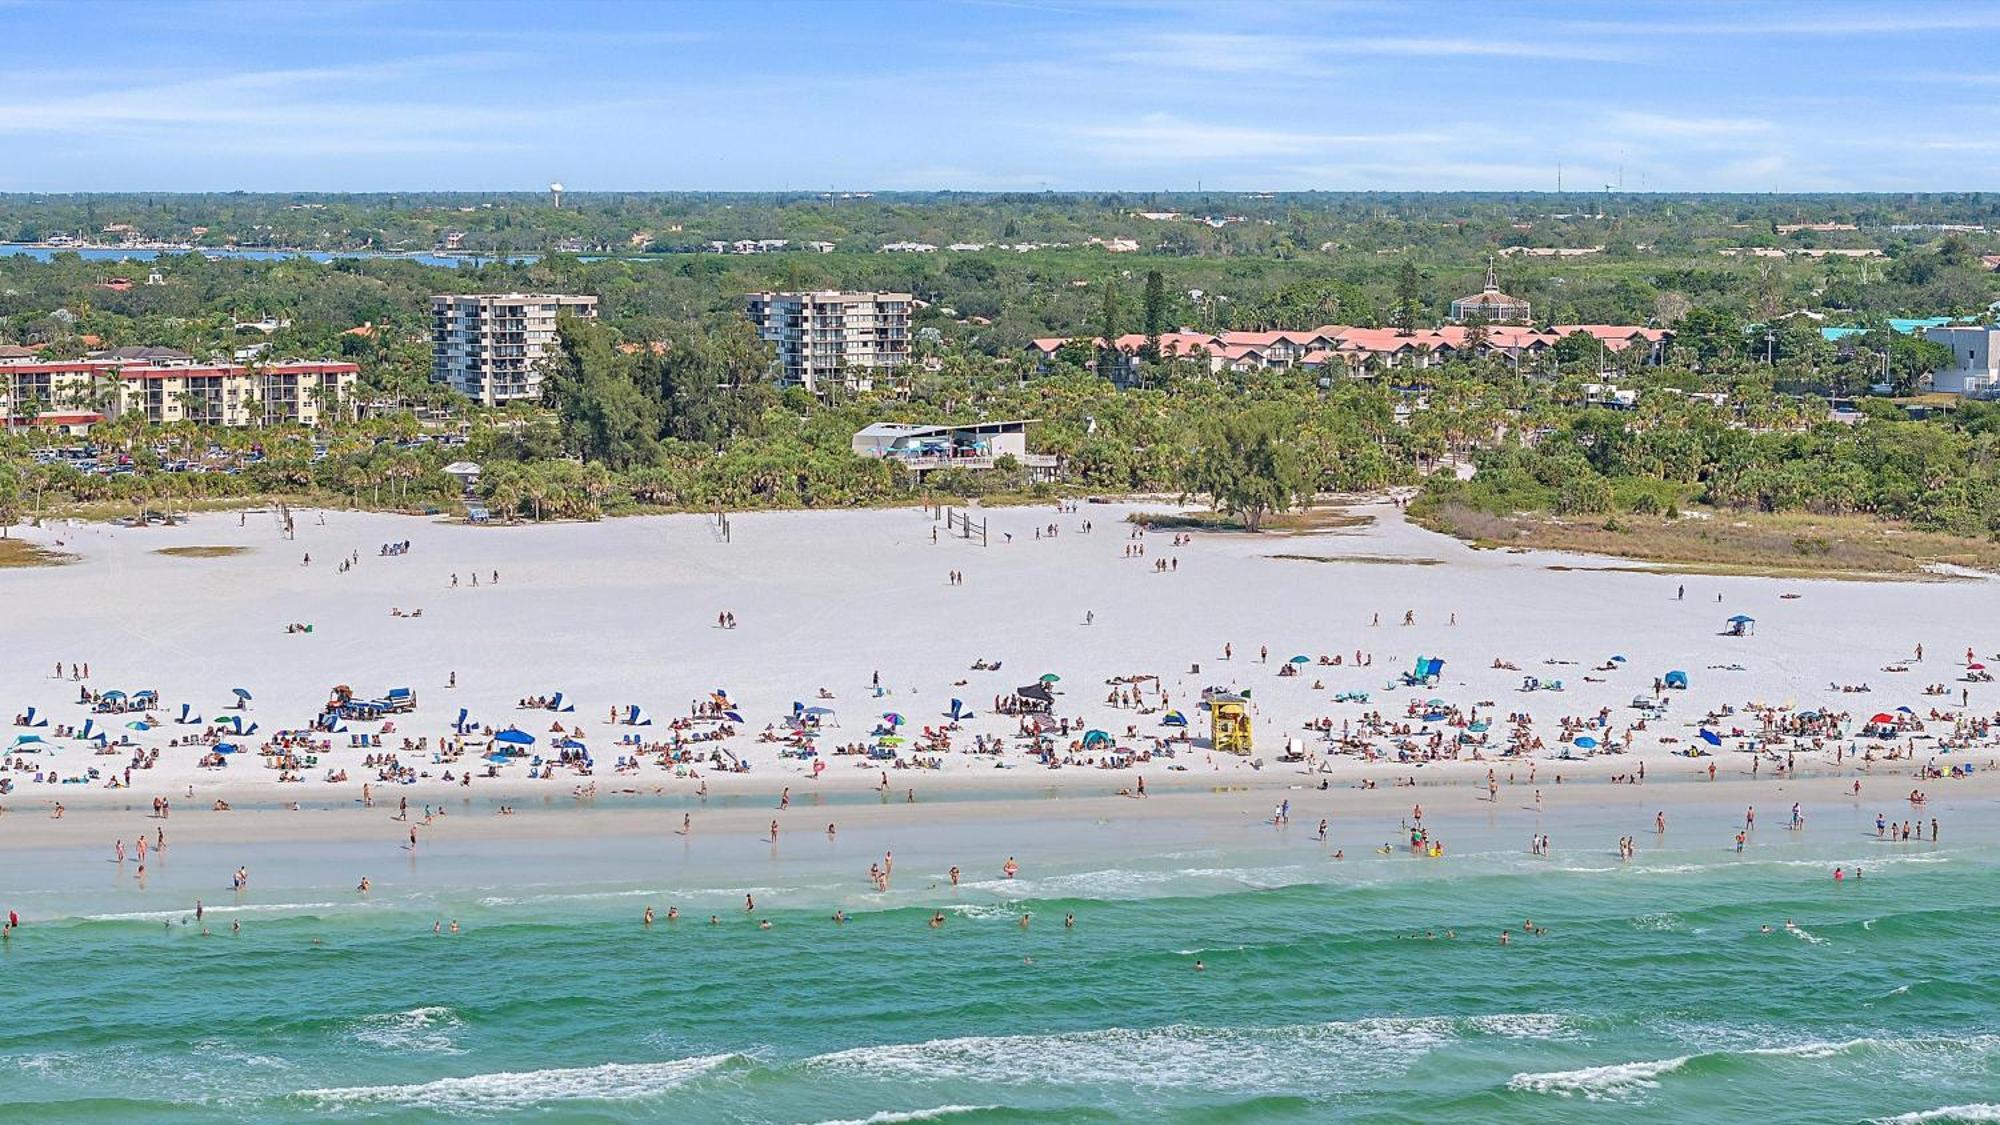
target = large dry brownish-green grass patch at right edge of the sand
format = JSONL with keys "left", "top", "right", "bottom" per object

{"left": 1412, "top": 504, "right": 2000, "bottom": 581}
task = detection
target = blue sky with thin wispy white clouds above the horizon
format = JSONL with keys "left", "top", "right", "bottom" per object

{"left": 0, "top": 0, "right": 2000, "bottom": 192}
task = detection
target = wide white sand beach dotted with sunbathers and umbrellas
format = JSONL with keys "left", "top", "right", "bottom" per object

{"left": 0, "top": 500, "right": 2000, "bottom": 811}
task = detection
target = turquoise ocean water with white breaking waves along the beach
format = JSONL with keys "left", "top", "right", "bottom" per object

{"left": 0, "top": 793, "right": 2000, "bottom": 1123}
